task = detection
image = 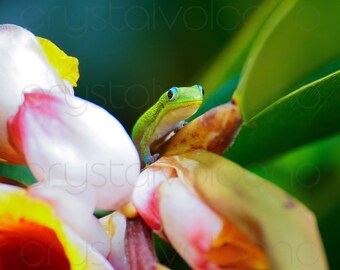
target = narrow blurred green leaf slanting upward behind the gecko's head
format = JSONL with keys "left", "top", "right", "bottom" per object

{"left": 200, "top": 0, "right": 281, "bottom": 98}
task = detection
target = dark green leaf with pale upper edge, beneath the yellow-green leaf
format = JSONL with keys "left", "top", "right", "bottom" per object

{"left": 225, "top": 71, "right": 340, "bottom": 165}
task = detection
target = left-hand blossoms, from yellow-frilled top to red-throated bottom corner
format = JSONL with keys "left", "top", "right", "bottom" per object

{"left": 0, "top": 25, "right": 140, "bottom": 269}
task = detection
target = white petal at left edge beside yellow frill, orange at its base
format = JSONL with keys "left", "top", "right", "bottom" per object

{"left": 0, "top": 24, "right": 69, "bottom": 162}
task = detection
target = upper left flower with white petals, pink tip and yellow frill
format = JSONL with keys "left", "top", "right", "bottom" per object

{"left": 0, "top": 25, "right": 140, "bottom": 211}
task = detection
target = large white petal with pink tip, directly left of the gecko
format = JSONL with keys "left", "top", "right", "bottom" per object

{"left": 9, "top": 93, "right": 140, "bottom": 210}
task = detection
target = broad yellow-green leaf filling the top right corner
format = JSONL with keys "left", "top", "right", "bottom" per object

{"left": 234, "top": 0, "right": 340, "bottom": 121}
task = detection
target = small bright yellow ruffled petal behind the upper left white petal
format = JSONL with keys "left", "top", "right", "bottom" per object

{"left": 37, "top": 37, "right": 80, "bottom": 86}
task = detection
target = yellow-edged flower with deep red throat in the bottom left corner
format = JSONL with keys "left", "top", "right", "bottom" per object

{"left": 0, "top": 184, "right": 113, "bottom": 270}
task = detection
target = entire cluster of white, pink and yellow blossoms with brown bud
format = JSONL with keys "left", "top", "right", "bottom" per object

{"left": 0, "top": 25, "right": 327, "bottom": 270}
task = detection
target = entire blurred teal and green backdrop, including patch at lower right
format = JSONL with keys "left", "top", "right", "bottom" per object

{"left": 0, "top": 0, "right": 340, "bottom": 269}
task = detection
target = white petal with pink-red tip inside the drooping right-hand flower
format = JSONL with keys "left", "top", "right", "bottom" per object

{"left": 160, "top": 178, "right": 223, "bottom": 269}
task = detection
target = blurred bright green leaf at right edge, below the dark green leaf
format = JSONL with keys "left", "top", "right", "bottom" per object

{"left": 247, "top": 134, "right": 340, "bottom": 221}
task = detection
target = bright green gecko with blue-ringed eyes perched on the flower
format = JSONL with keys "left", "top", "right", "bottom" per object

{"left": 132, "top": 85, "right": 204, "bottom": 165}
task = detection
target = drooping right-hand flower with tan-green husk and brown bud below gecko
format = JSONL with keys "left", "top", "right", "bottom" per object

{"left": 133, "top": 105, "right": 327, "bottom": 269}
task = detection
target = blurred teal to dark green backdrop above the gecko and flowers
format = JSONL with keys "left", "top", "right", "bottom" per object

{"left": 0, "top": 0, "right": 260, "bottom": 130}
